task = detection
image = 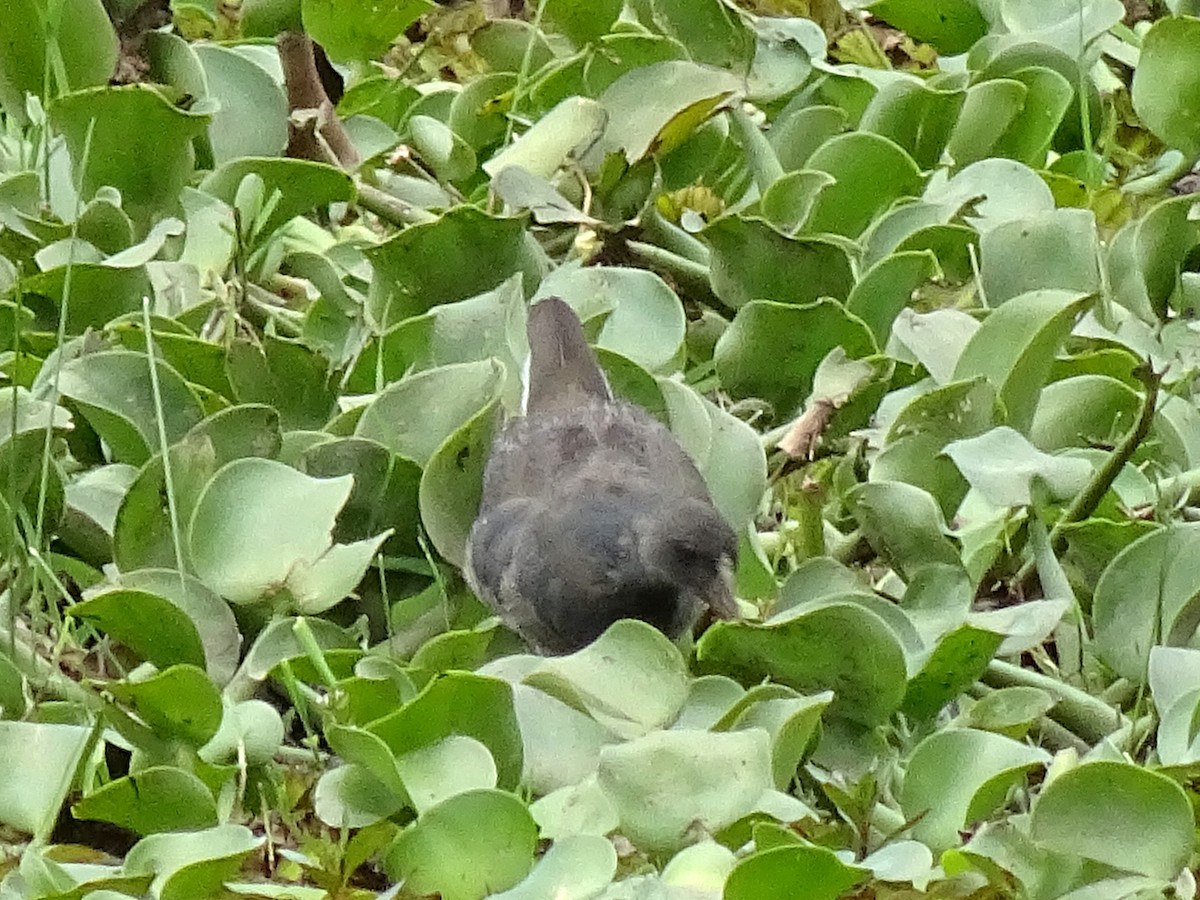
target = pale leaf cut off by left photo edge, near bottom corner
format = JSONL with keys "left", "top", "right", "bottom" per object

{"left": 0, "top": 721, "right": 91, "bottom": 838}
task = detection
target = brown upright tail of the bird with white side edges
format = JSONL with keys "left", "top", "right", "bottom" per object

{"left": 524, "top": 296, "right": 612, "bottom": 415}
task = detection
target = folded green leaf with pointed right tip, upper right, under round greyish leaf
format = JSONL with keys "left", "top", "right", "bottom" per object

{"left": 954, "top": 289, "right": 1092, "bottom": 433}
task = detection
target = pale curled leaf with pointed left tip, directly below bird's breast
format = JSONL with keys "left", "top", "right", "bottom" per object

{"left": 524, "top": 619, "right": 688, "bottom": 737}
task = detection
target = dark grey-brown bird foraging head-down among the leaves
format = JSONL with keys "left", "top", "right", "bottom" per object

{"left": 464, "top": 296, "right": 738, "bottom": 655}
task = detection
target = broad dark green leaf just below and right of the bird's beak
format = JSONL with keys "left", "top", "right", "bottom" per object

{"left": 696, "top": 602, "right": 907, "bottom": 725}
